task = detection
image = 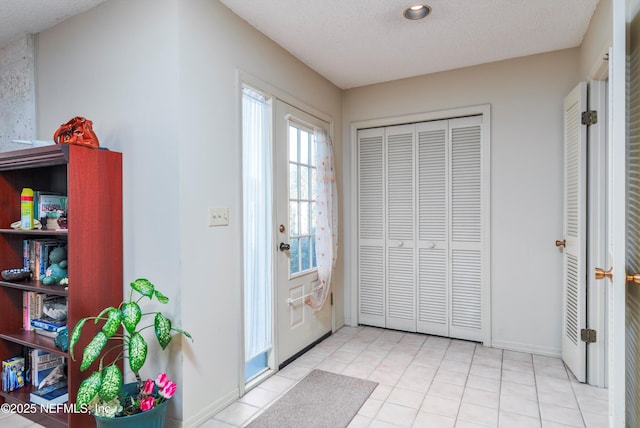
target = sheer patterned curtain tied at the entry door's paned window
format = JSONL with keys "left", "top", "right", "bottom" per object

{"left": 307, "top": 128, "right": 338, "bottom": 310}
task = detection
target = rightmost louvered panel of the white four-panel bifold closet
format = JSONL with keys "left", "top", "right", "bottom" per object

{"left": 449, "top": 116, "right": 484, "bottom": 341}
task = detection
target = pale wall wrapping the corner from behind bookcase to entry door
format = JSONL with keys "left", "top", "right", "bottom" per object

{"left": 37, "top": 0, "right": 343, "bottom": 426}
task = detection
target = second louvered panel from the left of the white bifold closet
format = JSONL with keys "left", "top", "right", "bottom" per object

{"left": 385, "top": 125, "right": 416, "bottom": 331}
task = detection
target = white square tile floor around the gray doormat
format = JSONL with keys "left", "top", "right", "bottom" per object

{"left": 200, "top": 327, "right": 608, "bottom": 428}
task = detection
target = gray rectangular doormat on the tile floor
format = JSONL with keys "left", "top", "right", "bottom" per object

{"left": 247, "top": 370, "right": 378, "bottom": 428}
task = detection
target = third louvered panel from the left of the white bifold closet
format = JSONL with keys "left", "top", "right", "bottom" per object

{"left": 416, "top": 120, "right": 450, "bottom": 336}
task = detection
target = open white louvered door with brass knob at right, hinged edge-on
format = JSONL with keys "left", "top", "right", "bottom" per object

{"left": 562, "top": 82, "right": 587, "bottom": 382}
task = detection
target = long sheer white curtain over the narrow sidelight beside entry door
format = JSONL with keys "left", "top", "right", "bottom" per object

{"left": 242, "top": 88, "right": 272, "bottom": 361}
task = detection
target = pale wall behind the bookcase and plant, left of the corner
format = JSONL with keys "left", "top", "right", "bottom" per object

{"left": 36, "top": 0, "right": 182, "bottom": 419}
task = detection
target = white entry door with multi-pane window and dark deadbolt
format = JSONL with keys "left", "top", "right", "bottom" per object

{"left": 274, "top": 100, "right": 331, "bottom": 366}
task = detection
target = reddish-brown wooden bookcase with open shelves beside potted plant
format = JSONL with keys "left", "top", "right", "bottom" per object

{"left": 0, "top": 145, "right": 123, "bottom": 428}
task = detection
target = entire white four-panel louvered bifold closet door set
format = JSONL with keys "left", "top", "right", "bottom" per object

{"left": 358, "top": 116, "right": 488, "bottom": 341}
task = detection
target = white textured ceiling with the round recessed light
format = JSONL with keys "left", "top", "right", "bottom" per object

{"left": 220, "top": 0, "right": 598, "bottom": 89}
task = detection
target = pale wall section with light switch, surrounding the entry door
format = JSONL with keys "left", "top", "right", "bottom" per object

{"left": 174, "top": 0, "right": 343, "bottom": 421}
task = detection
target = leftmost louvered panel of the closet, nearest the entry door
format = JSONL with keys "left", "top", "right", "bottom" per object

{"left": 358, "top": 128, "right": 386, "bottom": 327}
